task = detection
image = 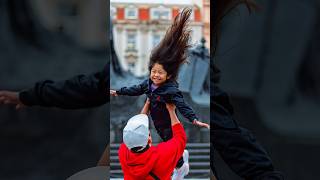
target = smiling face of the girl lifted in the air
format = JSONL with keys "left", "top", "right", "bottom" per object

{"left": 150, "top": 63, "right": 170, "bottom": 86}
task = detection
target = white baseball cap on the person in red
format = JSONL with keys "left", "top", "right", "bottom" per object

{"left": 123, "top": 114, "right": 149, "bottom": 149}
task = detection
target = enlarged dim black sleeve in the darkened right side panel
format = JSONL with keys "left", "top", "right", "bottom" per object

{"left": 210, "top": 86, "right": 282, "bottom": 179}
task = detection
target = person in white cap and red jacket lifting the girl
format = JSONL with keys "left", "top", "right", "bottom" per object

{"left": 119, "top": 100, "right": 187, "bottom": 180}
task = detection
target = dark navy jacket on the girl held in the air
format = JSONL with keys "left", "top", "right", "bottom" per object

{"left": 117, "top": 79, "right": 198, "bottom": 129}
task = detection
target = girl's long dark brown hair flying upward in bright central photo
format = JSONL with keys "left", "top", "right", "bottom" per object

{"left": 149, "top": 8, "right": 192, "bottom": 80}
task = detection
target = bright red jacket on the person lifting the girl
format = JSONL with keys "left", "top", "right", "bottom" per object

{"left": 119, "top": 123, "right": 187, "bottom": 180}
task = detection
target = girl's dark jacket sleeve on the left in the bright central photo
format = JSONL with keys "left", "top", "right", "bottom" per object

{"left": 117, "top": 80, "right": 148, "bottom": 96}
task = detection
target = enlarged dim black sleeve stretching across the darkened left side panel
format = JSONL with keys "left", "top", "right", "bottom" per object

{"left": 19, "top": 64, "right": 109, "bottom": 109}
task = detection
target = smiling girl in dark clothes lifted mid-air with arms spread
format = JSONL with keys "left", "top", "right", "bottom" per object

{"left": 110, "top": 9, "right": 210, "bottom": 179}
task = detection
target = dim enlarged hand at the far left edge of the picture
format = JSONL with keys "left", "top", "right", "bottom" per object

{"left": 0, "top": 91, "right": 25, "bottom": 109}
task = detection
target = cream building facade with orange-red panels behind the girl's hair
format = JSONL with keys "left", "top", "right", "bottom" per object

{"left": 110, "top": 0, "right": 203, "bottom": 76}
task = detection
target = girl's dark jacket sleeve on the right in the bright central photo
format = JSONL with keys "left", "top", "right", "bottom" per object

{"left": 172, "top": 92, "right": 198, "bottom": 123}
